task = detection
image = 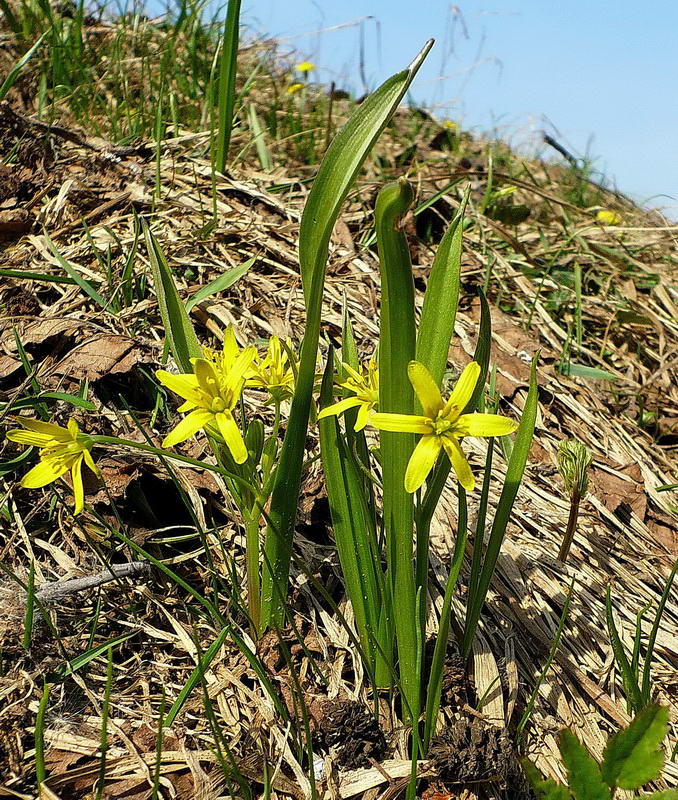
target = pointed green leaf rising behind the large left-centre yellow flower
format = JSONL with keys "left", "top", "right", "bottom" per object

{"left": 141, "top": 219, "right": 202, "bottom": 372}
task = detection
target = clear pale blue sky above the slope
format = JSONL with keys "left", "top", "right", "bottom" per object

{"left": 241, "top": 0, "right": 678, "bottom": 218}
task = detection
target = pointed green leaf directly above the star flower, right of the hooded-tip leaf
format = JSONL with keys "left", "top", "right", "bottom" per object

{"left": 417, "top": 188, "right": 470, "bottom": 386}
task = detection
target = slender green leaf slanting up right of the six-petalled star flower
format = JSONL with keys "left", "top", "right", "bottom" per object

{"left": 462, "top": 356, "right": 538, "bottom": 658}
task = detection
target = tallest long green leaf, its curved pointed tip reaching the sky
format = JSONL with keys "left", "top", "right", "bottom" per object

{"left": 262, "top": 42, "right": 433, "bottom": 627}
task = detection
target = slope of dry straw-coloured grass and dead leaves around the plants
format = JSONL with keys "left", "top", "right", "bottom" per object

{"left": 0, "top": 4, "right": 678, "bottom": 797}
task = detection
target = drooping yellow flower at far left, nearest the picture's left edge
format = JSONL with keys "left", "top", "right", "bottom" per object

{"left": 7, "top": 417, "right": 101, "bottom": 514}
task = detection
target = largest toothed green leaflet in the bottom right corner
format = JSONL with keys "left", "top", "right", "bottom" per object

{"left": 602, "top": 703, "right": 669, "bottom": 789}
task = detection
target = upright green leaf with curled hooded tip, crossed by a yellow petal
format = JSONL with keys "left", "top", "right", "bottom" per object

{"left": 375, "top": 179, "right": 421, "bottom": 722}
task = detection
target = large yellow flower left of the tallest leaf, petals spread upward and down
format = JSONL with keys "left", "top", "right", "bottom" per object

{"left": 155, "top": 326, "right": 257, "bottom": 464}
